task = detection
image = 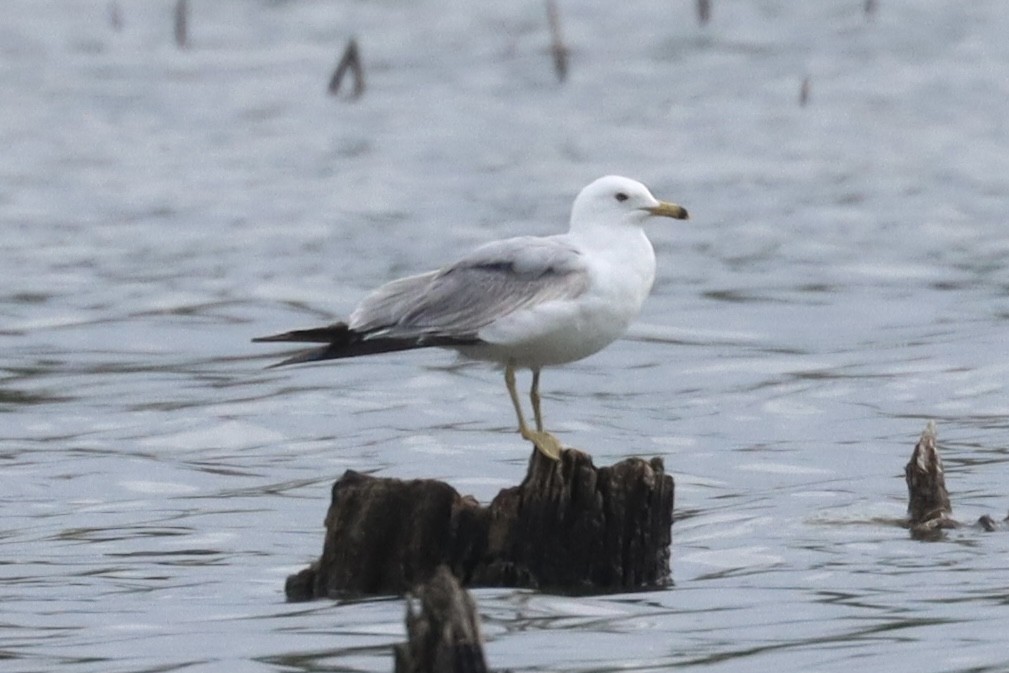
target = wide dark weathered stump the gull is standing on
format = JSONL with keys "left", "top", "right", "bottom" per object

{"left": 286, "top": 449, "right": 674, "bottom": 600}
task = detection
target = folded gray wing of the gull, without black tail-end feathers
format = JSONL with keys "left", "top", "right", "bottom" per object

{"left": 350, "top": 236, "right": 588, "bottom": 338}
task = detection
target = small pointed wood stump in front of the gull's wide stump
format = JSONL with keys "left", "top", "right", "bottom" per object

{"left": 395, "top": 565, "right": 487, "bottom": 673}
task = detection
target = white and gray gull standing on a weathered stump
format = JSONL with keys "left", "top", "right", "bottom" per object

{"left": 253, "top": 176, "right": 687, "bottom": 460}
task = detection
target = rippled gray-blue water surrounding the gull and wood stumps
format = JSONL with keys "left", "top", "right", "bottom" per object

{"left": 0, "top": 0, "right": 1009, "bottom": 673}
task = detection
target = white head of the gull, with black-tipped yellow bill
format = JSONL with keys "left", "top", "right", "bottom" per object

{"left": 571, "top": 176, "right": 687, "bottom": 230}
